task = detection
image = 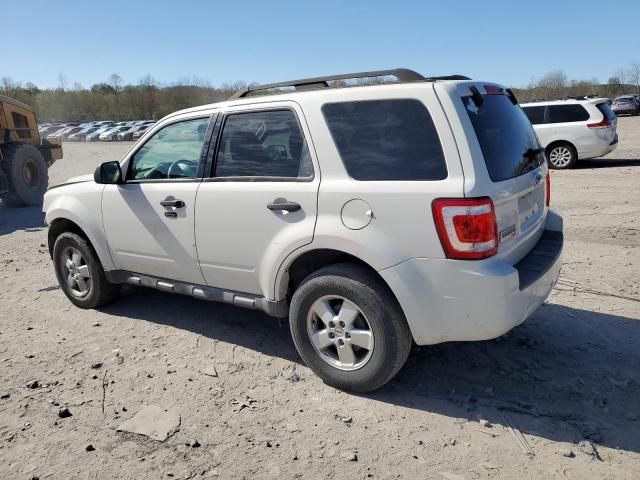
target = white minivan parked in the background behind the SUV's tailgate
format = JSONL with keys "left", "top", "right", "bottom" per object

{"left": 521, "top": 98, "right": 618, "bottom": 169}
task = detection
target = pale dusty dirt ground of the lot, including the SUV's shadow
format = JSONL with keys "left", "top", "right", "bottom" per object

{"left": 0, "top": 117, "right": 640, "bottom": 480}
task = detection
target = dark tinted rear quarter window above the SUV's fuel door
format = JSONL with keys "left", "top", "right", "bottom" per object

{"left": 322, "top": 99, "right": 447, "bottom": 180}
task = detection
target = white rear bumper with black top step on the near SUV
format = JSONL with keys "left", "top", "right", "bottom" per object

{"left": 380, "top": 210, "right": 563, "bottom": 345}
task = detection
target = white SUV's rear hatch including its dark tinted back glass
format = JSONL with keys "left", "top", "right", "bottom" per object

{"left": 436, "top": 82, "right": 548, "bottom": 265}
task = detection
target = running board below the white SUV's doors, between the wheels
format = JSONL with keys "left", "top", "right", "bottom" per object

{"left": 104, "top": 270, "right": 289, "bottom": 318}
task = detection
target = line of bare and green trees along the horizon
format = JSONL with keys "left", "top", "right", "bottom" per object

{"left": 0, "top": 62, "right": 640, "bottom": 122}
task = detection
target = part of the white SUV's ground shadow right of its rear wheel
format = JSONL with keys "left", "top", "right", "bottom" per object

{"left": 367, "top": 304, "right": 640, "bottom": 452}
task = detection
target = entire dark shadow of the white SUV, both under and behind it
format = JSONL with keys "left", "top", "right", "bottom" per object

{"left": 102, "top": 287, "right": 640, "bottom": 453}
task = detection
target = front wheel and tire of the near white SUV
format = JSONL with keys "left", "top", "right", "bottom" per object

{"left": 53, "top": 232, "right": 120, "bottom": 308}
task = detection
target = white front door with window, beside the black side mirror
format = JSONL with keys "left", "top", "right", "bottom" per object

{"left": 102, "top": 116, "right": 209, "bottom": 284}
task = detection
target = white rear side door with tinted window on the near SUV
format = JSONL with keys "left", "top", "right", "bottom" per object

{"left": 195, "top": 101, "right": 320, "bottom": 297}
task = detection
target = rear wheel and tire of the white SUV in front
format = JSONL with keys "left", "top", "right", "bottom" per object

{"left": 289, "top": 263, "right": 413, "bottom": 392}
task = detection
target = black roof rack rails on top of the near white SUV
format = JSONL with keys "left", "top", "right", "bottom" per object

{"left": 229, "top": 68, "right": 469, "bottom": 100}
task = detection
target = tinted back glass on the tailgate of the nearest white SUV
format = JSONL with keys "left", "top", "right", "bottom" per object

{"left": 462, "top": 95, "right": 544, "bottom": 182}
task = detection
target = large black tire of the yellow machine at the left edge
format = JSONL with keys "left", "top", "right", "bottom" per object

{"left": 2, "top": 143, "right": 49, "bottom": 206}
